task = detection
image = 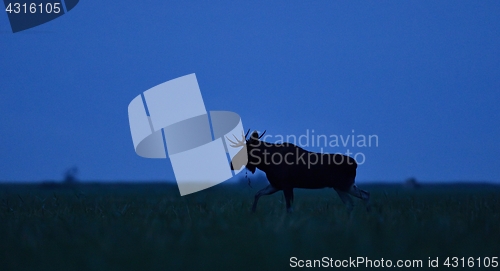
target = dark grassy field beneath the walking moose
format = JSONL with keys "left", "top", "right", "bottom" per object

{"left": 0, "top": 184, "right": 500, "bottom": 270}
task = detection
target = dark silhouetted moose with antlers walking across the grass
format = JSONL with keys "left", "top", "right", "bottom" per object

{"left": 226, "top": 130, "right": 370, "bottom": 212}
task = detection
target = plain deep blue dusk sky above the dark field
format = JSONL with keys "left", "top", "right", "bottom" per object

{"left": 0, "top": 1, "right": 500, "bottom": 182}
